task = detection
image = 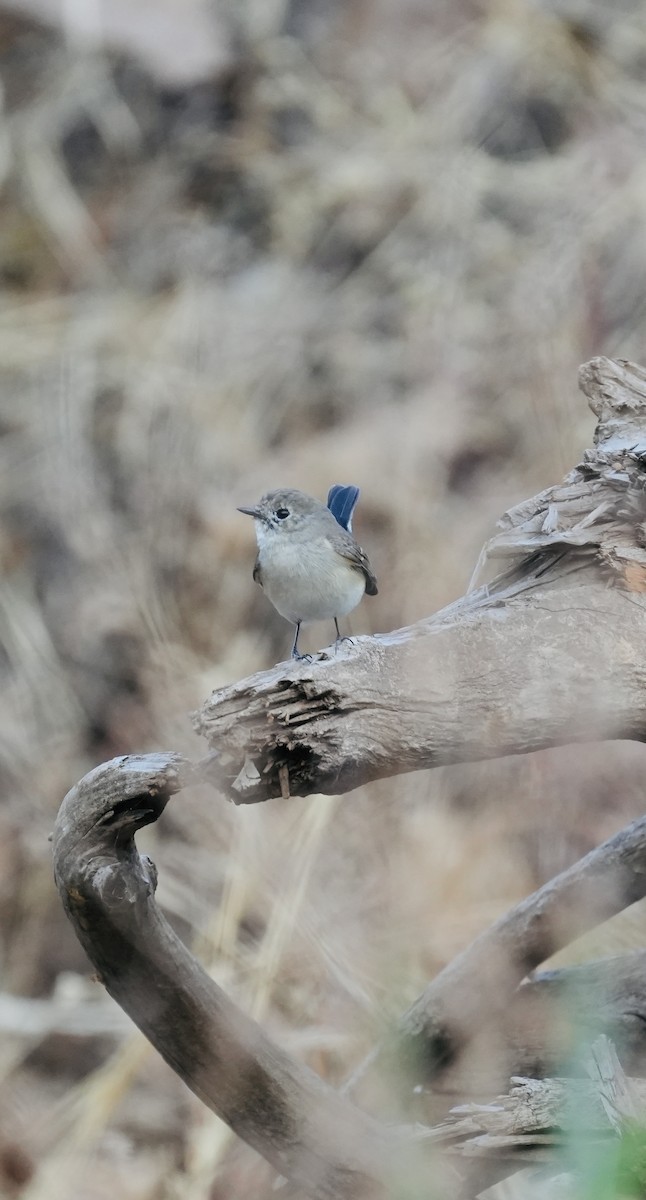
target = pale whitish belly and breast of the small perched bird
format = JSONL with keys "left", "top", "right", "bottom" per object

{"left": 261, "top": 538, "right": 365, "bottom": 624}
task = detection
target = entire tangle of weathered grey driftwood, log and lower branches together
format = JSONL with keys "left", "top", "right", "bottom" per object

{"left": 54, "top": 359, "right": 646, "bottom": 1200}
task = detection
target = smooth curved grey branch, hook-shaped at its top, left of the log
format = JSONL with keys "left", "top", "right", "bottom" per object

{"left": 54, "top": 754, "right": 396, "bottom": 1200}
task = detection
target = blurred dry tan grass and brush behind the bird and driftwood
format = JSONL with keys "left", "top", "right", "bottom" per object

{"left": 0, "top": 0, "right": 646, "bottom": 1200}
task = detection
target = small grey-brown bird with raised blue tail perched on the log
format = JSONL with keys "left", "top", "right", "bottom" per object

{"left": 238, "top": 484, "right": 377, "bottom": 659}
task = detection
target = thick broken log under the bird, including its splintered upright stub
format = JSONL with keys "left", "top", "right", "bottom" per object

{"left": 196, "top": 359, "right": 646, "bottom": 803}
